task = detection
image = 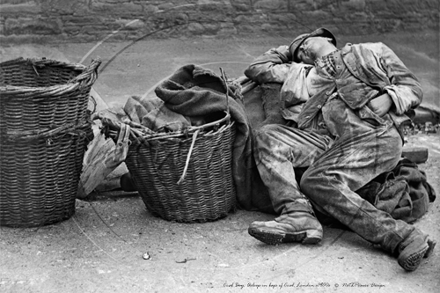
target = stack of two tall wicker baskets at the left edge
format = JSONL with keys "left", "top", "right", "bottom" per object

{"left": 0, "top": 58, "right": 101, "bottom": 227}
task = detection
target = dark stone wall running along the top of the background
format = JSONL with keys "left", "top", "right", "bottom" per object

{"left": 0, "top": 0, "right": 439, "bottom": 43}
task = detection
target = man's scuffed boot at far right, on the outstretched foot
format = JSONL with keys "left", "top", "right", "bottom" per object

{"left": 397, "top": 229, "right": 436, "bottom": 271}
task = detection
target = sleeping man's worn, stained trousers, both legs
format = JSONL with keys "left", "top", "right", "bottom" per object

{"left": 254, "top": 115, "right": 414, "bottom": 253}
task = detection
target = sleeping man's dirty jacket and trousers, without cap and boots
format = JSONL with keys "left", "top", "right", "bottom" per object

{"left": 245, "top": 43, "right": 422, "bottom": 252}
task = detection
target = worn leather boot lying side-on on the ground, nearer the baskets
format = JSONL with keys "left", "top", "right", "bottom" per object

{"left": 248, "top": 212, "right": 322, "bottom": 245}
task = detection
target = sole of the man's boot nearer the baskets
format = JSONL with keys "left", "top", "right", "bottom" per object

{"left": 248, "top": 228, "right": 322, "bottom": 245}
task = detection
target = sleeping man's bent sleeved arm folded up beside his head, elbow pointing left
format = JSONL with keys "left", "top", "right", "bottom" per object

{"left": 244, "top": 46, "right": 291, "bottom": 83}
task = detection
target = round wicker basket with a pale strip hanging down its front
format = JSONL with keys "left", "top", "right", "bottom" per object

{"left": 103, "top": 114, "right": 236, "bottom": 223}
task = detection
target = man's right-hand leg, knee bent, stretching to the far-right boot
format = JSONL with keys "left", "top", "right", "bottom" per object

{"left": 300, "top": 123, "right": 433, "bottom": 270}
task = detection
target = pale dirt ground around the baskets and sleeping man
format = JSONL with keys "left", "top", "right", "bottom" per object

{"left": 0, "top": 32, "right": 440, "bottom": 293}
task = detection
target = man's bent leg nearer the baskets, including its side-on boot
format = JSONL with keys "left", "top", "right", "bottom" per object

{"left": 249, "top": 124, "right": 330, "bottom": 244}
